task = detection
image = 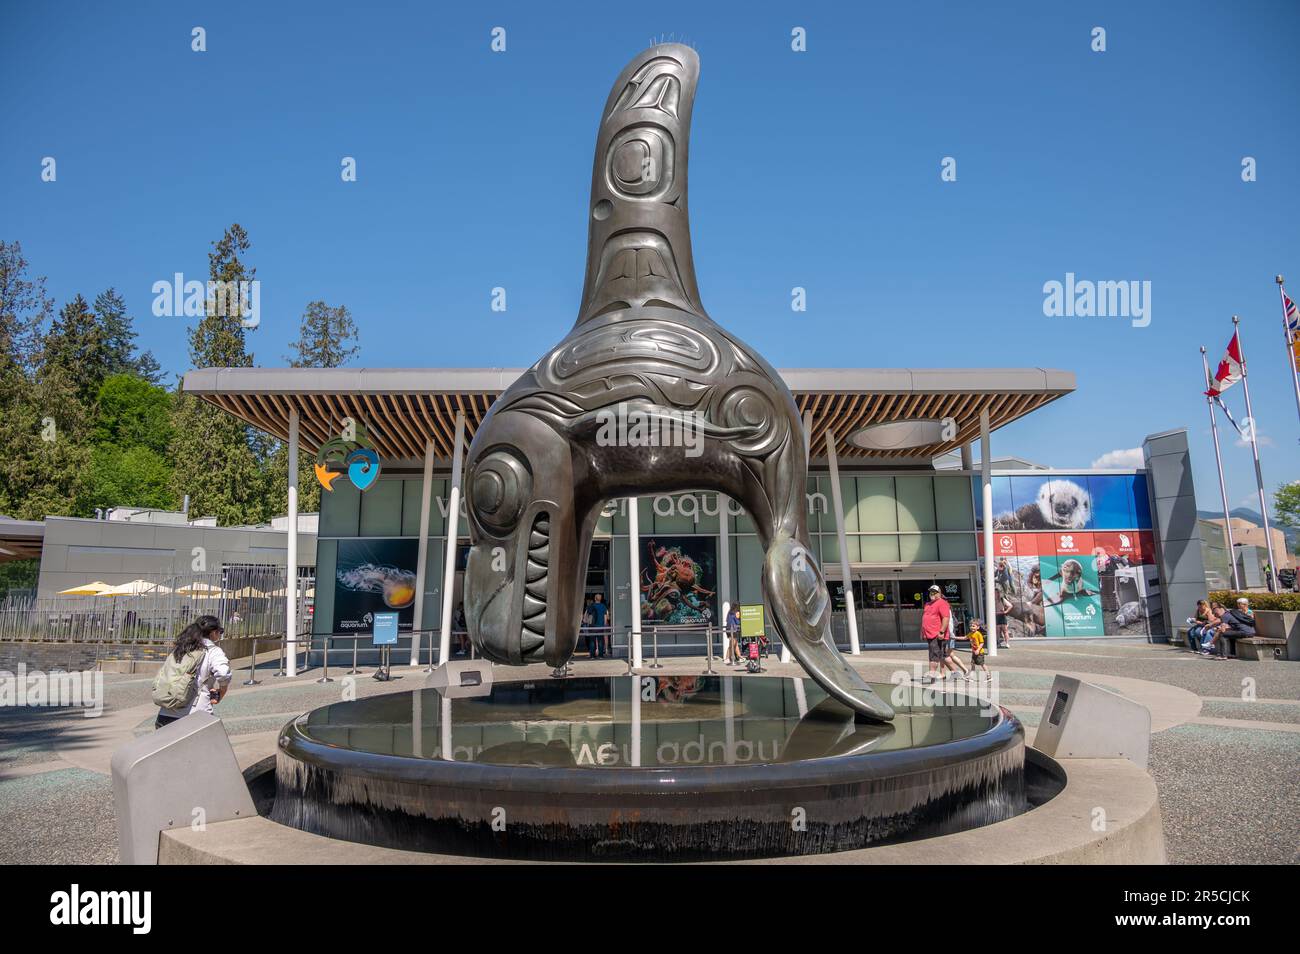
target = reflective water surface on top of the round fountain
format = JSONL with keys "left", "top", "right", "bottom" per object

{"left": 296, "top": 675, "right": 998, "bottom": 771}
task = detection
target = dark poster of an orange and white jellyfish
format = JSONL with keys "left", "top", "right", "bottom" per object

{"left": 334, "top": 539, "right": 419, "bottom": 633}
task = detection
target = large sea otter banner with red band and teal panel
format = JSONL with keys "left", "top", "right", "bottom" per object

{"left": 975, "top": 473, "right": 1166, "bottom": 637}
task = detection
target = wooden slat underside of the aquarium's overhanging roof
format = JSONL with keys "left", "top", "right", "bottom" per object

{"left": 202, "top": 391, "right": 1061, "bottom": 461}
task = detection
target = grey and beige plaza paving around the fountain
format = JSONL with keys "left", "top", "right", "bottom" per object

{"left": 0, "top": 641, "right": 1300, "bottom": 864}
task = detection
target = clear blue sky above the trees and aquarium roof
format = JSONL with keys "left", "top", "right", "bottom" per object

{"left": 0, "top": 0, "right": 1300, "bottom": 508}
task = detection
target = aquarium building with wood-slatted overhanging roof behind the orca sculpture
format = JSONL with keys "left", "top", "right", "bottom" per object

{"left": 183, "top": 368, "right": 1205, "bottom": 665}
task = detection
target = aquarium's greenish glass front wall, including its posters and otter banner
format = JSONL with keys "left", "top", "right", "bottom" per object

{"left": 313, "top": 471, "right": 1162, "bottom": 645}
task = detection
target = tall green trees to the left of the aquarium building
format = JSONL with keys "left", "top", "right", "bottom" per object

{"left": 0, "top": 224, "right": 358, "bottom": 530}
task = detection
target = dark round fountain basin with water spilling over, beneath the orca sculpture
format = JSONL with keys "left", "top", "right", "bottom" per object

{"left": 272, "top": 675, "right": 1027, "bottom": 862}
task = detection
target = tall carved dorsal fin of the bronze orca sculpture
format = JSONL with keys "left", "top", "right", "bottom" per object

{"left": 576, "top": 43, "right": 709, "bottom": 325}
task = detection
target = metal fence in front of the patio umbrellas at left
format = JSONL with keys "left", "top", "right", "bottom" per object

{"left": 0, "top": 564, "right": 315, "bottom": 642}
